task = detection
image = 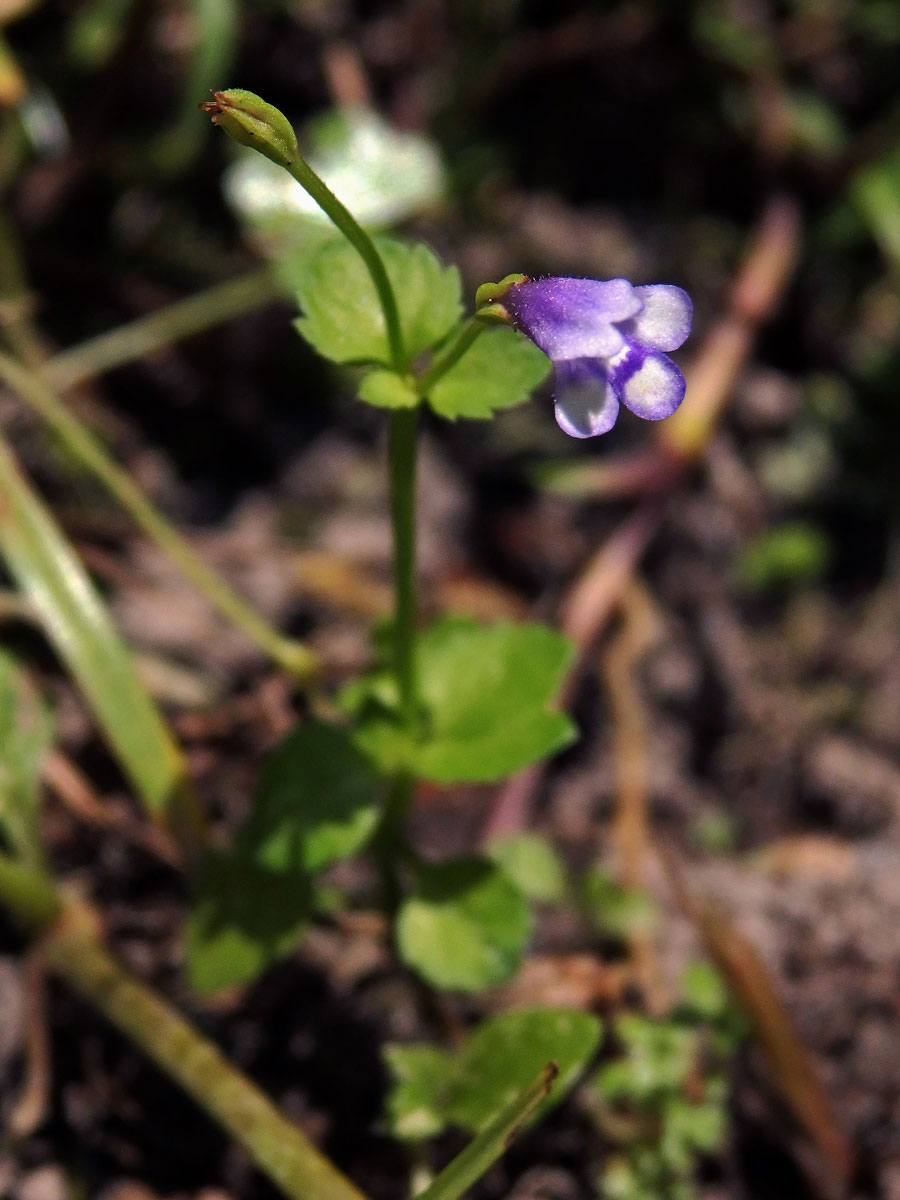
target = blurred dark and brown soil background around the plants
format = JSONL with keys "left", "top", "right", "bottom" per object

{"left": 0, "top": 7, "right": 900, "bottom": 1200}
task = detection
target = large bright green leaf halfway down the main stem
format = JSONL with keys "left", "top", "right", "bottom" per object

{"left": 340, "top": 617, "right": 575, "bottom": 784}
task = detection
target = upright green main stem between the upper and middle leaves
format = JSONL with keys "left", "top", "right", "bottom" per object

{"left": 389, "top": 408, "right": 419, "bottom": 732}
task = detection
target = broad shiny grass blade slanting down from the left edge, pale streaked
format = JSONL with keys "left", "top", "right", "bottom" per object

{"left": 0, "top": 443, "right": 191, "bottom": 820}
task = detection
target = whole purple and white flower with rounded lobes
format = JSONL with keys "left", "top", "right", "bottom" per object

{"left": 500, "top": 277, "right": 692, "bottom": 438}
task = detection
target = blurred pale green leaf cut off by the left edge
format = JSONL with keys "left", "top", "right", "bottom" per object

{"left": 0, "top": 650, "right": 55, "bottom": 866}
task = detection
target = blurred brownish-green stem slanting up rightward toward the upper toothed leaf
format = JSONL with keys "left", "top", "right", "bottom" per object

{"left": 43, "top": 266, "right": 280, "bottom": 390}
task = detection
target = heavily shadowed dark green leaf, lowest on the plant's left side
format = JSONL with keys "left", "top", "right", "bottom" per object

{"left": 186, "top": 853, "right": 312, "bottom": 992}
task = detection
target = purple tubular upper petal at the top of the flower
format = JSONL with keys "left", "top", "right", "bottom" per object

{"left": 503, "top": 277, "right": 642, "bottom": 362}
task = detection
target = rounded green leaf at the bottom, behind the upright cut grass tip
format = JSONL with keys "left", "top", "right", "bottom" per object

{"left": 445, "top": 1008, "right": 602, "bottom": 1129}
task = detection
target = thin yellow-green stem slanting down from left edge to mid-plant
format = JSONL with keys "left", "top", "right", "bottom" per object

{"left": 0, "top": 354, "right": 318, "bottom": 680}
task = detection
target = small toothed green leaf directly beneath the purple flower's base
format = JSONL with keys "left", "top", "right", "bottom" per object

{"left": 428, "top": 328, "right": 550, "bottom": 420}
